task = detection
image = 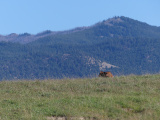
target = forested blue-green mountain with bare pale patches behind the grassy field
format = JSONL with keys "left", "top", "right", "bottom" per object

{"left": 0, "top": 16, "right": 160, "bottom": 80}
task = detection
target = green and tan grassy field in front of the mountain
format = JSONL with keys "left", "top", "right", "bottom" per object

{"left": 0, "top": 75, "right": 160, "bottom": 120}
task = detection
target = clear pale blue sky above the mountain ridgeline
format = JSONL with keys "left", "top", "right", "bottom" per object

{"left": 0, "top": 0, "right": 160, "bottom": 35}
